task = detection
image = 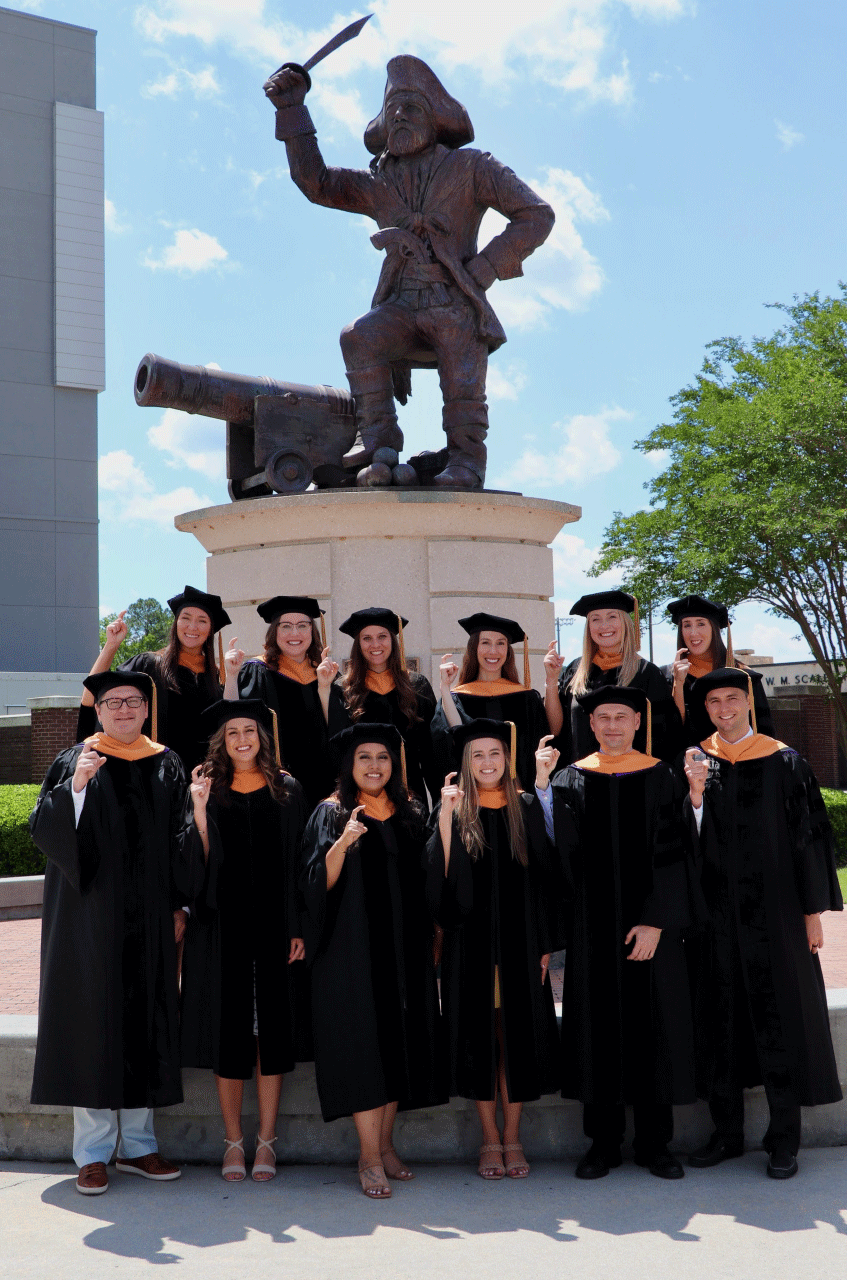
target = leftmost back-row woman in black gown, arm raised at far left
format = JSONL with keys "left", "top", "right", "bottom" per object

{"left": 77, "top": 586, "right": 230, "bottom": 773}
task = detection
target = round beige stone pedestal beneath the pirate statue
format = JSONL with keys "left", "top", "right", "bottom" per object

{"left": 174, "top": 489, "right": 582, "bottom": 687}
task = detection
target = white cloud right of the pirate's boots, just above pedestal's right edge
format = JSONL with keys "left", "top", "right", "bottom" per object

{"left": 491, "top": 407, "right": 633, "bottom": 489}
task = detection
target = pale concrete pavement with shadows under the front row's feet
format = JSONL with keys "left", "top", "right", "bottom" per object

{"left": 0, "top": 1148, "right": 847, "bottom": 1280}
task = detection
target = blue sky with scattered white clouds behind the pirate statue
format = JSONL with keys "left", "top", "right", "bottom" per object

{"left": 22, "top": 0, "right": 847, "bottom": 660}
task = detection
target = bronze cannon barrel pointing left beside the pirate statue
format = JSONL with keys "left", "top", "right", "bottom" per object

{"left": 136, "top": 352, "right": 356, "bottom": 426}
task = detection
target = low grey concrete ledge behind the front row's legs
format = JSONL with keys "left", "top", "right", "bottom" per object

{"left": 0, "top": 989, "right": 847, "bottom": 1164}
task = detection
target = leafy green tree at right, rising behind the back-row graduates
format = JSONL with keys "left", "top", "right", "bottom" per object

{"left": 591, "top": 284, "right": 847, "bottom": 751}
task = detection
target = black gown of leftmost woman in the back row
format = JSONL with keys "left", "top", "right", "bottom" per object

{"left": 77, "top": 653, "right": 223, "bottom": 774}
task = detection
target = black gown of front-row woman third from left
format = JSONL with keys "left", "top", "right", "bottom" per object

{"left": 301, "top": 803, "right": 448, "bottom": 1120}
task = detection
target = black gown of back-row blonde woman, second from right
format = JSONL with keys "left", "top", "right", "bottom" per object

{"left": 553, "top": 658, "right": 679, "bottom": 764}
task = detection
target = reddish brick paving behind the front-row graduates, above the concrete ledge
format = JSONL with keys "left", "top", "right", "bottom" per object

{"left": 0, "top": 910, "right": 847, "bottom": 1014}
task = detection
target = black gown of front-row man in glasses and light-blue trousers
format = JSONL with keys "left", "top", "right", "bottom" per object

{"left": 29, "top": 746, "right": 203, "bottom": 1110}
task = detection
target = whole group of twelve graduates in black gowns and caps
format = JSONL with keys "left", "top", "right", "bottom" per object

{"left": 31, "top": 586, "right": 842, "bottom": 1199}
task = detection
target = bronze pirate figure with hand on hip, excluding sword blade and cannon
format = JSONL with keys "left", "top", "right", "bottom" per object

{"left": 265, "top": 55, "right": 554, "bottom": 489}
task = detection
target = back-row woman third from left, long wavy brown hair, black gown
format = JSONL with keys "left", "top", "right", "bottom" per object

{"left": 339, "top": 607, "right": 443, "bottom": 808}
